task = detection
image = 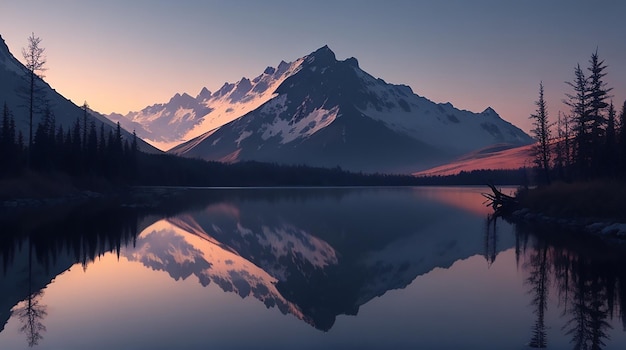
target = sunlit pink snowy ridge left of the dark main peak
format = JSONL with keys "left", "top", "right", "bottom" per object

{"left": 108, "top": 60, "right": 302, "bottom": 150}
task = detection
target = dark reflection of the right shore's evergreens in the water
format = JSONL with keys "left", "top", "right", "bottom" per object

{"left": 516, "top": 225, "right": 626, "bottom": 349}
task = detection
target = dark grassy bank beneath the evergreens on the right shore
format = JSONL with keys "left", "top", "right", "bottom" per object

{"left": 517, "top": 180, "right": 626, "bottom": 220}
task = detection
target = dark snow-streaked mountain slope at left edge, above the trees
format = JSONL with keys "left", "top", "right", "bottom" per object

{"left": 0, "top": 36, "right": 160, "bottom": 153}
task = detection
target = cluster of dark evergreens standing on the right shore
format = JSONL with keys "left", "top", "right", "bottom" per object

{"left": 530, "top": 50, "right": 626, "bottom": 184}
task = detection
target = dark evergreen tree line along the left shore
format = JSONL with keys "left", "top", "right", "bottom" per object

{"left": 0, "top": 103, "right": 139, "bottom": 183}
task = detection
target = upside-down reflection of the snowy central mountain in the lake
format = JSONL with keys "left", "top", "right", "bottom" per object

{"left": 121, "top": 189, "right": 502, "bottom": 330}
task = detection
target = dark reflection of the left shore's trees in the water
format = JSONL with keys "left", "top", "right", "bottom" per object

{"left": 0, "top": 202, "right": 145, "bottom": 347}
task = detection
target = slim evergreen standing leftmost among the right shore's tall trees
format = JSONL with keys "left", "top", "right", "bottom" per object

{"left": 530, "top": 82, "right": 551, "bottom": 184}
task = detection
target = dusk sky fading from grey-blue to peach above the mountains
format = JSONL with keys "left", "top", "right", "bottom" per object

{"left": 0, "top": 0, "right": 626, "bottom": 132}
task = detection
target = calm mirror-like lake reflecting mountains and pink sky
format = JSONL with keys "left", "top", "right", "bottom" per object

{"left": 0, "top": 187, "right": 626, "bottom": 349}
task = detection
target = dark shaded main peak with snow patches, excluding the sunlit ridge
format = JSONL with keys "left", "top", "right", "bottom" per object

{"left": 169, "top": 46, "right": 532, "bottom": 173}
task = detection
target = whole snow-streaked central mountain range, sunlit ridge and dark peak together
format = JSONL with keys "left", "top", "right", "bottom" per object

{"left": 108, "top": 46, "right": 532, "bottom": 172}
